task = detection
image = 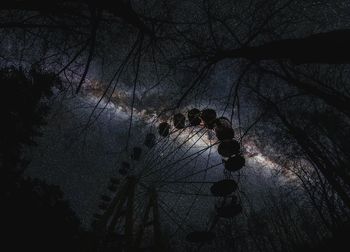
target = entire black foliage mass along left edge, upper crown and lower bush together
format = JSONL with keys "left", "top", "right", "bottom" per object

{"left": 0, "top": 68, "right": 93, "bottom": 251}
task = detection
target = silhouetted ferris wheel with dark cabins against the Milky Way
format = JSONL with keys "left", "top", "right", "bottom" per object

{"left": 92, "top": 108, "right": 245, "bottom": 251}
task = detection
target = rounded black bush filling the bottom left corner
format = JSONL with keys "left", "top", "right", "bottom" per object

{"left": 1, "top": 178, "right": 82, "bottom": 251}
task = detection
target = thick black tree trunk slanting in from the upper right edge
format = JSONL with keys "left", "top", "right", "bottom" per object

{"left": 216, "top": 30, "right": 350, "bottom": 64}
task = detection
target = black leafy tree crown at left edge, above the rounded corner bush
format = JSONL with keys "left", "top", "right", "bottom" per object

{"left": 0, "top": 67, "right": 61, "bottom": 181}
